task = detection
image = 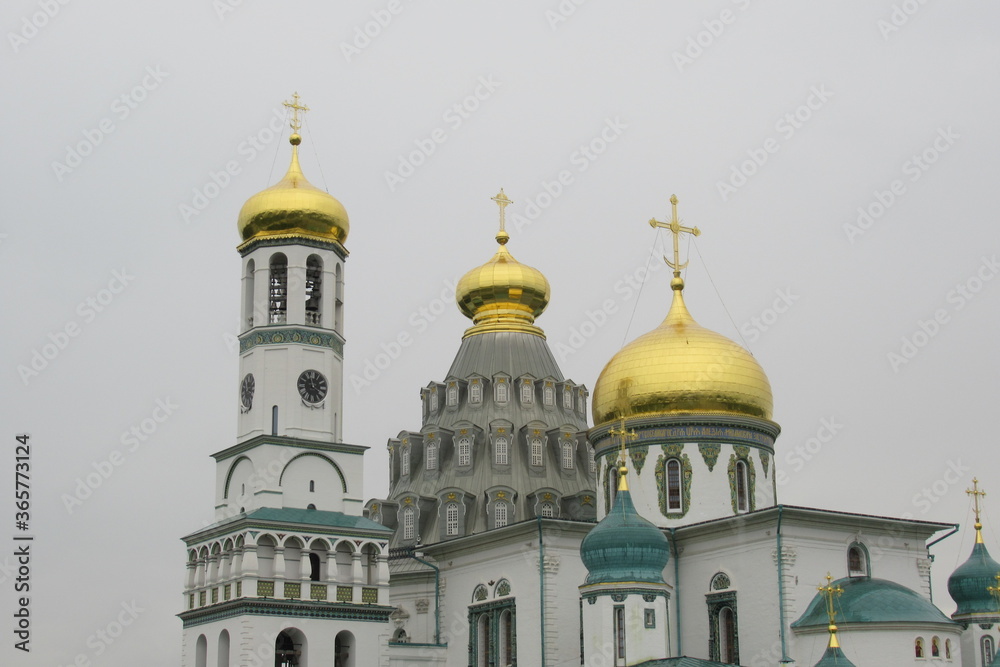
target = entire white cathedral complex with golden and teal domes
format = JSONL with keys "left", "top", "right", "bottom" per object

{"left": 179, "top": 96, "right": 1000, "bottom": 667}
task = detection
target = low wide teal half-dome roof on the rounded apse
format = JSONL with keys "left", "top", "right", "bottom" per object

{"left": 792, "top": 577, "right": 957, "bottom": 628}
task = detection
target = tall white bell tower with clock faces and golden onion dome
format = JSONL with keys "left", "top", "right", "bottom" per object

{"left": 179, "top": 94, "right": 393, "bottom": 667}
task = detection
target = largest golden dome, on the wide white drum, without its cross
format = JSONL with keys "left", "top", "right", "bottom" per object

{"left": 593, "top": 278, "right": 773, "bottom": 426}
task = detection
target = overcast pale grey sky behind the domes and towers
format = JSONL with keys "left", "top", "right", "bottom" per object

{"left": 0, "top": 0, "right": 1000, "bottom": 666}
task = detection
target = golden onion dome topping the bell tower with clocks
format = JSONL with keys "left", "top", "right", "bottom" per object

{"left": 238, "top": 133, "right": 351, "bottom": 244}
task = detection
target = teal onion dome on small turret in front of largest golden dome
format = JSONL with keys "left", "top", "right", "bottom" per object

{"left": 580, "top": 490, "right": 670, "bottom": 584}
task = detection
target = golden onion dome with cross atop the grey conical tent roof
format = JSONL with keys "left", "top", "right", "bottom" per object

{"left": 455, "top": 189, "right": 550, "bottom": 337}
